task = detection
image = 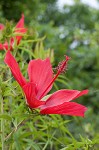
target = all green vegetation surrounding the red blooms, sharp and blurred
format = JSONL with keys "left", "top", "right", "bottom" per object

{"left": 0, "top": 0, "right": 99, "bottom": 150}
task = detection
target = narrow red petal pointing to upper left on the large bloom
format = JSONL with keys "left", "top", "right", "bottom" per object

{"left": 4, "top": 51, "right": 26, "bottom": 86}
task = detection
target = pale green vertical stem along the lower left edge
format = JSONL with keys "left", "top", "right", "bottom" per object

{"left": 0, "top": 89, "right": 4, "bottom": 150}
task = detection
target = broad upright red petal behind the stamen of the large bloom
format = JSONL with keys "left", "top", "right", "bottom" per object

{"left": 28, "top": 58, "right": 53, "bottom": 99}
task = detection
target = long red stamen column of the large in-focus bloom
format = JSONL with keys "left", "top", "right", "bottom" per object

{"left": 40, "top": 56, "right": 70, "bottom": 99}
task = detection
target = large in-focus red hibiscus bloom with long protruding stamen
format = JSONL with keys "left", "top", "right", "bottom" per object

{"left": 4, "top": 51, "right": 88, "bottom": 117}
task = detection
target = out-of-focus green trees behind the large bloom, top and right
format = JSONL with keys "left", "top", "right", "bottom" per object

{"left": 0, "top": 0, "right": 99, "bottom": 150}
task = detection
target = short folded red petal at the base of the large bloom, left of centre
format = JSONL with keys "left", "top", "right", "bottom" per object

{"left": 23, "top": 83, "right": 45, "bottom": 108}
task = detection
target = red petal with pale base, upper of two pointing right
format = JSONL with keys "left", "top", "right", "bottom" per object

{"left": 44, "top": 90, "right": 88, "bottom": 108}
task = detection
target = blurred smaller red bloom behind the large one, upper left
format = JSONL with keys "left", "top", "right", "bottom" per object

{"left": 0, "top": 14, "right": 27, "bottom": 50}
